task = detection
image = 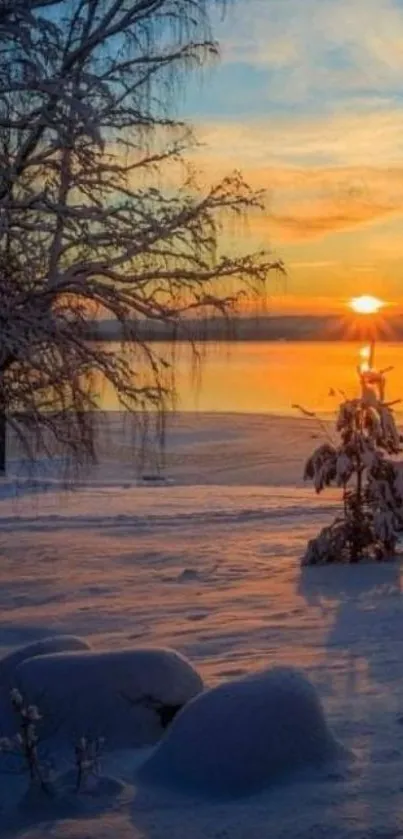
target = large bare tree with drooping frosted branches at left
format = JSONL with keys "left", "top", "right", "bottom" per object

{"left": 0, "top": 0, "right": 281, "bottom": 470}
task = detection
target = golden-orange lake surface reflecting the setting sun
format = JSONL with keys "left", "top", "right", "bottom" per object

{"left": 101, "top": 341, "right": 403, "bottom": 416}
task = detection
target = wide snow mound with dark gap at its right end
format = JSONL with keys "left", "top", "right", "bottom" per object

{"left": 13, "top": 648, "right": 203, "bottom": 749}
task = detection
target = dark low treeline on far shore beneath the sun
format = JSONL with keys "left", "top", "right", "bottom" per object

{"left": 88, "top": 315, "right": 403, "bottom": 342}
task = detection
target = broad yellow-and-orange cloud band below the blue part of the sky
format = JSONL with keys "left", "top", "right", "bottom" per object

{"left": 188, "top": 110, "right": 403, "bottom": 243}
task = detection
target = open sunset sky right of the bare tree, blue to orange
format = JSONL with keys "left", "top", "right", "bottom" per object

{"left": 183, "top": 0, "right": 403, "bottom": 311}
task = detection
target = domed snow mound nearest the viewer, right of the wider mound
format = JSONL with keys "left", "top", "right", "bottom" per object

{"left": 138, "top": 667, "right": 347, "bottom": 796}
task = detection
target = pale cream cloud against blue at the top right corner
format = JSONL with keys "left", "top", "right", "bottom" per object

{"left": 218, "top": 0, "right": 403, "bottom": 101}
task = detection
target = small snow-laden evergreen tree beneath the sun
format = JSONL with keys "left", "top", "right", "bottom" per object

{"left": 302, "top": 362, "right": 403, "bottom": 565}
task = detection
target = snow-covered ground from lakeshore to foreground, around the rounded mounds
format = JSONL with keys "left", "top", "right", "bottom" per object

{"left": 0, "top": 416, "right": 403, "bottom": 839}
